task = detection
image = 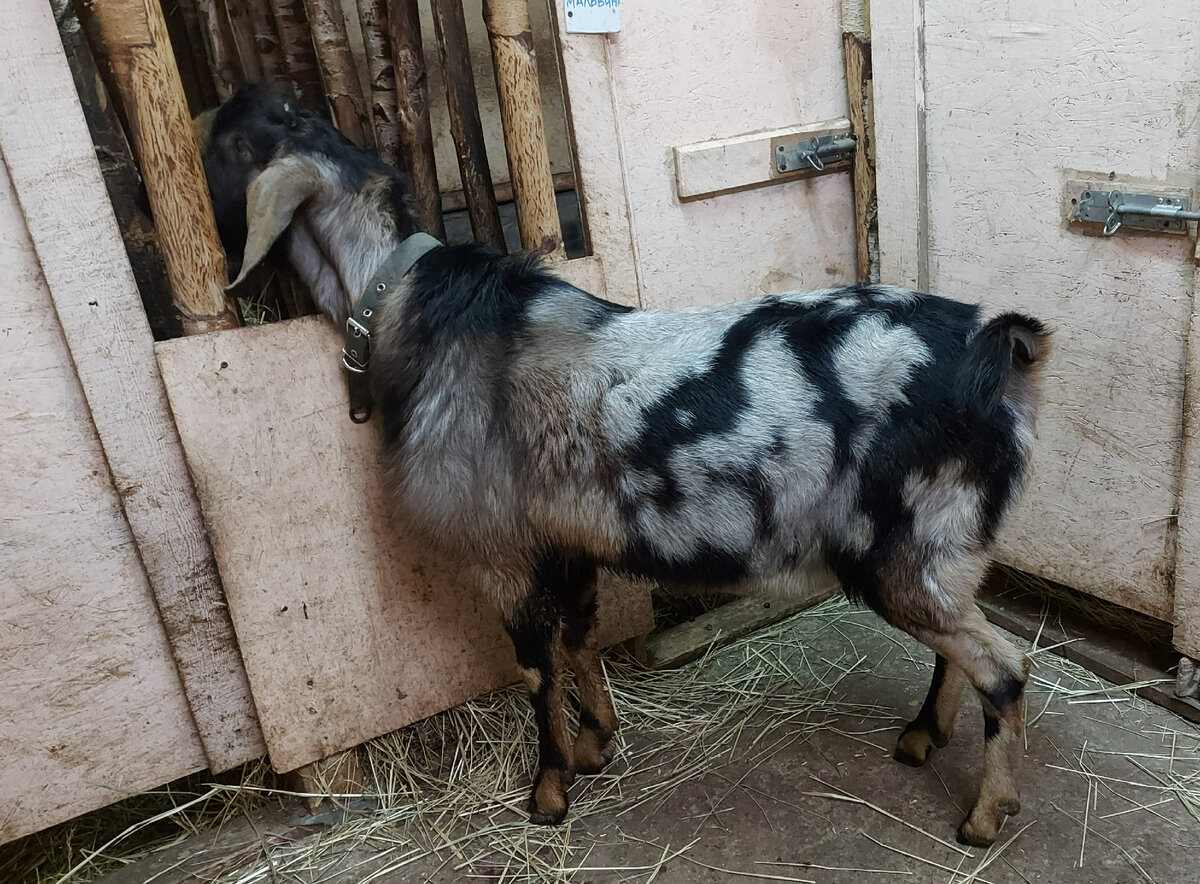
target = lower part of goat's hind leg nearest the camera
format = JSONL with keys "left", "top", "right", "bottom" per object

{"left": 913, "top": 606, "right": 1030, "bottom": 847}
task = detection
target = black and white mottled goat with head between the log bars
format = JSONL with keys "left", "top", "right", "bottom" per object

{"left": 197, "top": 88, "right": 1048, "bottom": 844}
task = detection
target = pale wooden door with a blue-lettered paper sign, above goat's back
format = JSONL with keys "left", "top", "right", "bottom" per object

{"left": 550, "top": 0, "right": 854, "bottom": 307}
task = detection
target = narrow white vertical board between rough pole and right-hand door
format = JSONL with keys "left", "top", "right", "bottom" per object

{"left": 870, "top": 0, "right": 929, "bottom": 289}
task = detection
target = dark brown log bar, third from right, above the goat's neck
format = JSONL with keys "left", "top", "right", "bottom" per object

{"left": 388, "top": 0, "right": 445, "bottom": 239}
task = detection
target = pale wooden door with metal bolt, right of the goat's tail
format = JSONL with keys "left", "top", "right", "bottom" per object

{"left": 871, "top": 0, "right": 1200, "bottom": 619}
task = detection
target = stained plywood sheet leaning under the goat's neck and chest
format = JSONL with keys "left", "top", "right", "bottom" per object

{"left": 157, "top": 317, "right": 650, "bottom": 770}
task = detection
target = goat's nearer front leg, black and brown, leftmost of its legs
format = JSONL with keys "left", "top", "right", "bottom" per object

{"left": 505, "top": 591, "right": 572, "bottom": 825}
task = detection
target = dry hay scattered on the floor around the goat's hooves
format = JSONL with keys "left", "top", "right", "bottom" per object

{"left": 9, "top": 597, "right": 1200, "bottom": 884}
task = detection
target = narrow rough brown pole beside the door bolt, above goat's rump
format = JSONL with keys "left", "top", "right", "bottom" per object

{"left": 841, "top": 31, "right": 880, "bottom": 283}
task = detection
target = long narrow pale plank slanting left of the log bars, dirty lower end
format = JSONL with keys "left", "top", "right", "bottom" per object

{"left": 0, "top": 0, "right": 264, "bottom": 771}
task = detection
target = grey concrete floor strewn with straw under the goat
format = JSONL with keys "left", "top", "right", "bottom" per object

{"left": 98, "top": 612, "right": 1200, "bottom": 884}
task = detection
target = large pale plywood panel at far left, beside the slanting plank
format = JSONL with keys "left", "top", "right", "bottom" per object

{"left": 0, "top": 162, "right": 205, "bottom": 843}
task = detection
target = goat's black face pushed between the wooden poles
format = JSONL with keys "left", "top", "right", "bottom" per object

{"left": 193, "top": 84, "right": 319, "bottom": 257}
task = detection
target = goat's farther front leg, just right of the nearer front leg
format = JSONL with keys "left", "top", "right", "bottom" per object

{"left": 563, "top": 566, "right": 617, "bottom": 774}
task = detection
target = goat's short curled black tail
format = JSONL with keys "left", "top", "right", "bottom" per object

{"left": 954, "top": 313, "right": 1050, "bottom": 414}
